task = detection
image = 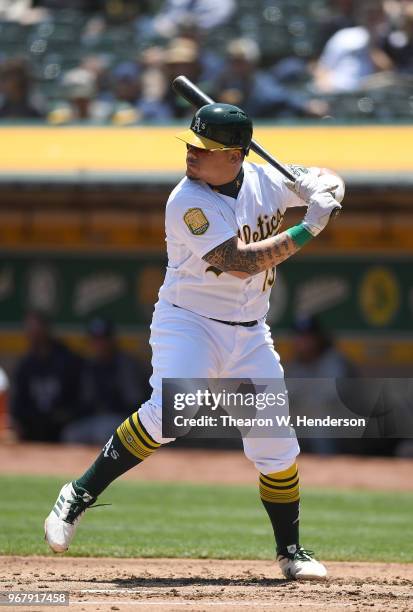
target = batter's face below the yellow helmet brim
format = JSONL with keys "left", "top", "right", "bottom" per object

{"left": 186, "top": 145, "right": 242, "bottom": 185}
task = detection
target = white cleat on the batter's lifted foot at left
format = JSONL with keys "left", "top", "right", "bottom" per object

{"left": 44, "top": 482, "right": 96, "bottom": 552}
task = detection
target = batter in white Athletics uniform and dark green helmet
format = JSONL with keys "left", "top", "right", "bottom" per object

{"left": 45, "top": 104, "right": 343, "bottom": 580}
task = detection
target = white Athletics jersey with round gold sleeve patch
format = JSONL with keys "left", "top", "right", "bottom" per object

{"left": 159, "top": 162, "right": 305, "bottom": 322}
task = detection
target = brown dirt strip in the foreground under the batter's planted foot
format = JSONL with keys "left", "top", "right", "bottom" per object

{"left": 0, "top": 557, "right": 413, "bottom": 612}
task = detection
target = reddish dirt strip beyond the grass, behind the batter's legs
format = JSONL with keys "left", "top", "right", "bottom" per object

{"left": 0, "top": 443, "right": 413, "bottom": 491}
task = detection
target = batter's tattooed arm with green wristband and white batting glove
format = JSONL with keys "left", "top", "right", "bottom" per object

{"left": 203, "top": 181, "right": 339, "bottom": 278}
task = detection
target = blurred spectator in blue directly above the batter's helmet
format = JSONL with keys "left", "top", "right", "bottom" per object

{"left": 215, "top": 38, "right": 327, "bottom": 118}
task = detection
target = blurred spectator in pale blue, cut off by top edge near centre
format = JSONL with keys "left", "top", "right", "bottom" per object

{"left": 153, "top": 0, "right": 236, "bottom": 38}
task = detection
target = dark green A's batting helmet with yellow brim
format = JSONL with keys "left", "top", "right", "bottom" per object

{"left": 177, "top": 103, "right": 252, "bottom": 153}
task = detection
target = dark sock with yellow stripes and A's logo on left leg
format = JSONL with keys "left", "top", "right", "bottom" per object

{"left": 73, "top": 412, "right": 161, "bottom": 497}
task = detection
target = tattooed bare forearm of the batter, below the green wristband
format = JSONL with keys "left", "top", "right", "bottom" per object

{"left": 203, "top": 232, "right": 300, "bottom": 275}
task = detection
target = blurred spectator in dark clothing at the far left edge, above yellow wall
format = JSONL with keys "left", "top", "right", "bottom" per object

{"left": 0, "top": 58, "right": 43, "bottom": 119}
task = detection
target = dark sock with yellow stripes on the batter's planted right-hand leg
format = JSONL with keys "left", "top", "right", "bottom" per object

{"left": 260, "top": 463, "right": 300, "bottom": 554}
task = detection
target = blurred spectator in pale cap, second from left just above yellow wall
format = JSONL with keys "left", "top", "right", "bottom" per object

{"left": 48, "top": 68, "right": 111, "bottom": 124}
